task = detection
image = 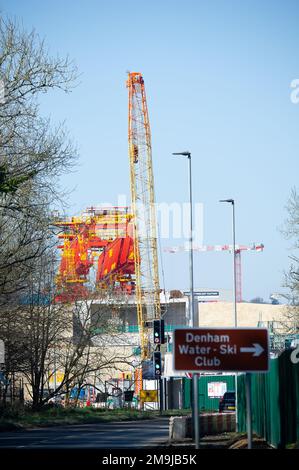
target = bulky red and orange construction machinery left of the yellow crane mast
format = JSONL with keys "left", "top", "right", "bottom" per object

{"left": 54, "top": 207, "right": 135, "bottom": 302}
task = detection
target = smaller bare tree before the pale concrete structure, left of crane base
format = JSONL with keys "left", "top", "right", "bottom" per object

{"left": 55, "top": 292, "right": 133, "bottom": 410}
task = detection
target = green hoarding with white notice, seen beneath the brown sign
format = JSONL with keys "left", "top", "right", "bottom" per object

{"left": 183, "top": 375, "right": 235, "bottom": 411}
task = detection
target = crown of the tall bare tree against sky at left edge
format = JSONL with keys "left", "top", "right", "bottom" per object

{"left": 0, "top": 18, "right": 77, "bottom": 304}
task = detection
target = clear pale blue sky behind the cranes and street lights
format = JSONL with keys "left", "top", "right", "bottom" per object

{"left": 0, "top": 0, "right": 299, "bottom": 300}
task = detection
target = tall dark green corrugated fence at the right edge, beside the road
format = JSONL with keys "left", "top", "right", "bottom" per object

{"left": 238, "top": 350, "right": 299, "bottom": 448}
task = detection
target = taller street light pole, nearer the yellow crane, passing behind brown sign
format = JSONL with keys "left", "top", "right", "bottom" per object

{"left": 173, "top": 151, "right": 199, "bottom": 449}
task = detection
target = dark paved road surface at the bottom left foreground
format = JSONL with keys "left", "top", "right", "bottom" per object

{"left": 0, "top": 418, "right": 169, "bottom": 449}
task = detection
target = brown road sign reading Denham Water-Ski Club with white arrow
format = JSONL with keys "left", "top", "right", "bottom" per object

{"left": 173, "top": 328, "right": 269, "bottom": 372}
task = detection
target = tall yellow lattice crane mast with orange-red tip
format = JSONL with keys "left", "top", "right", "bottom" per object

{"left": 127, "top": 72, "right": 161, "bottom": 360}
